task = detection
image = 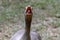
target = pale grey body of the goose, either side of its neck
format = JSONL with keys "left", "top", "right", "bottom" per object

{"left": 11, "top": 30, "right": 41, "bottom": 40}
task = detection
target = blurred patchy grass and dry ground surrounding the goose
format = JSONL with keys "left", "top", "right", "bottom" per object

{"left": 0, "top": 0, "right": 60, "bottom": 40}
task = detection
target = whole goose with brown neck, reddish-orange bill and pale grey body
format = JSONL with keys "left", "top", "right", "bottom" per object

{"left": 10, "top": 5, "right": 41, "bottom": 40}
